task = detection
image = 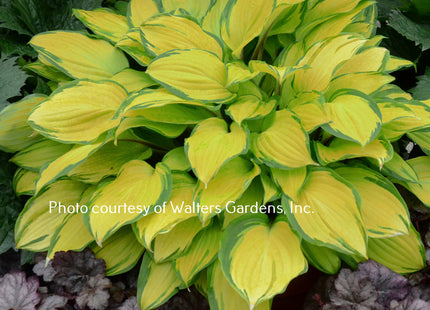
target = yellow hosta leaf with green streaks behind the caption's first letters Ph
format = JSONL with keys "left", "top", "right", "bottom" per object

{"left": 15, "top": 180, "right": 86, "bottom": 252}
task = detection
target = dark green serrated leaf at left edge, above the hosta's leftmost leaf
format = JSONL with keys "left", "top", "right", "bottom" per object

{"left": 0, "top": 57, "right": 27, "bottom": 110}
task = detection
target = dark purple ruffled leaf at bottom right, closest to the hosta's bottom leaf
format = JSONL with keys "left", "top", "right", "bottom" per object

{"left": 323, "top": 269, "right": 384, "bottom": 310}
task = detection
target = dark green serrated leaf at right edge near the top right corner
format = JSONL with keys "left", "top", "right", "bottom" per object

{"left": 388, "top": 10, "right": 430, "bottom": 51}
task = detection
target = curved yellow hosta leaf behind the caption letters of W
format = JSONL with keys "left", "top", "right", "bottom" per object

{"left": 133, "top": 173, "right": 197, "bottom": 251}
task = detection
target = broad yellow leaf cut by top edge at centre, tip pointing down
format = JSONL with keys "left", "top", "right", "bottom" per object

{"left": 221, "top": 0, "right": 275, "bottom": 57}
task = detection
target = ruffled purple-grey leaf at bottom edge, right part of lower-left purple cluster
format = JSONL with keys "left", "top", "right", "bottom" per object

{"left": 76, "top": 274, "right": 112, "bottom": 310}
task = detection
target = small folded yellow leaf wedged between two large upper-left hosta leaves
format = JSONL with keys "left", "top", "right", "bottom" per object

{"left": 115, "top": 28, "right": 152, "bottom": 67}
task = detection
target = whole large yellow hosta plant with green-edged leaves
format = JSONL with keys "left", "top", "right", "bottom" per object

{"left": 0, "top": 0, "right": 430, "bottom": 310}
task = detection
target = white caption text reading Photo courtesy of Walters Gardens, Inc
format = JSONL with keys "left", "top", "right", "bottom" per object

{"left": 49, "top": 201, "right": 314, "bottom": 216}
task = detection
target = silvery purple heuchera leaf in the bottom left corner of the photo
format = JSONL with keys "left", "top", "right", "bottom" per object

{"left": 0, "top": 272, "right": 40, "bottom": 310}
